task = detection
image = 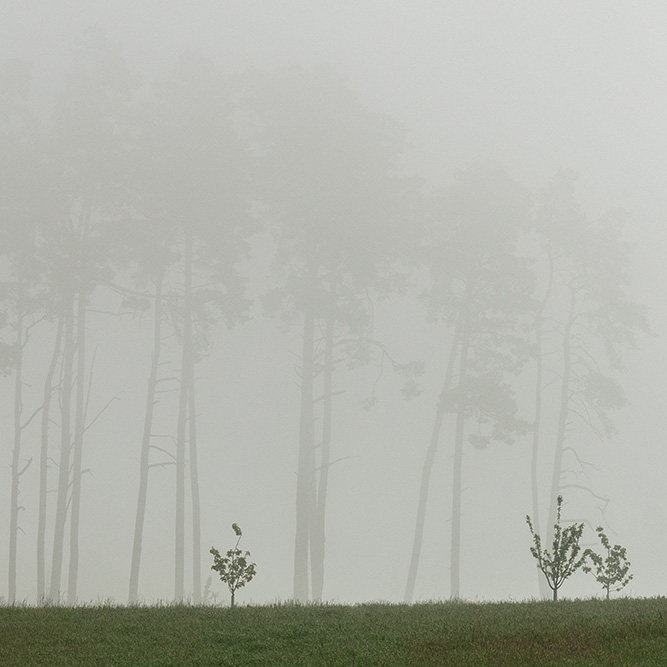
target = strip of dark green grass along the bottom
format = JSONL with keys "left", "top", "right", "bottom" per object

{"left": 0, "top": 598, "right": 667, "bottom": 667}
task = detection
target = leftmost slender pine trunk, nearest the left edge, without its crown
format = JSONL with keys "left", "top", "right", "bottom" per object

{"left": 7, "top": 270, "right": 25, "bottom": 604}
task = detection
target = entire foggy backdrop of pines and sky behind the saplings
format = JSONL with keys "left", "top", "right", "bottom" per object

{"left": 0, "top": 0, "right": 667, "bottom": 604}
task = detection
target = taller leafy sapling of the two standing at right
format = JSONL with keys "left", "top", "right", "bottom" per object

{"left": 526, "top": 496, "right": 587, "bottom": 602}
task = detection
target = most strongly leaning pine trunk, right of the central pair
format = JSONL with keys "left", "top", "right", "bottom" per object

{"left": 403, "top": 322, "right": 461, "bottom": 603}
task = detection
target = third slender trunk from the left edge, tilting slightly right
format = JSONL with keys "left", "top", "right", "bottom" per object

{"left": 49, "top": 290, "right": 74, "bottom": 603}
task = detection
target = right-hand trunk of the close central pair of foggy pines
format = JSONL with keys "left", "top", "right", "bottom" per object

{"left": 310, "top": 312, "right": 336, "bottom": 601}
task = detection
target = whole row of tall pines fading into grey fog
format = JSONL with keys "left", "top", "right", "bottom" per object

{"left": 0, "top": 42, "right": 647, "bottom": 603}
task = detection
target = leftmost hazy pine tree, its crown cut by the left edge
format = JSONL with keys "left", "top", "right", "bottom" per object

{"left": 0, "top": 61, "right": 44, "bottom": 603}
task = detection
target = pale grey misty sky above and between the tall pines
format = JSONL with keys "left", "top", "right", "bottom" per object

{"left": 0, "top": 0, "right": 667, "bottom": 602}
